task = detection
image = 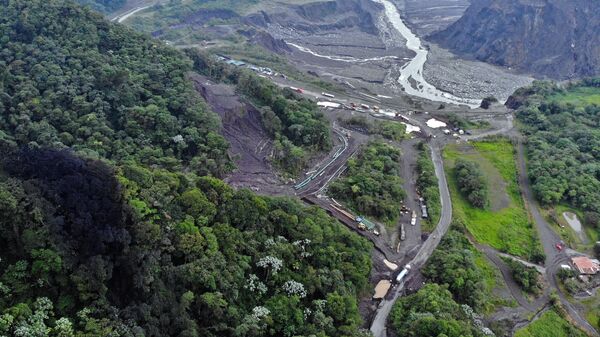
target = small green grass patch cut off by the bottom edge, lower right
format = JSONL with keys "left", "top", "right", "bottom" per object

{"left": 515, "top": 310, "right": 587, "bottom": 337}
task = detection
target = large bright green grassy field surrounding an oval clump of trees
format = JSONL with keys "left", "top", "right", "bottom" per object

{"left": 444, "top": 140, "right": 541, "bottom": 260}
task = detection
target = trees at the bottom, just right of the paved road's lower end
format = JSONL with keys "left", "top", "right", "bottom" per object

{"left": 390, "top": 230, "right": 495, "bottom": 337}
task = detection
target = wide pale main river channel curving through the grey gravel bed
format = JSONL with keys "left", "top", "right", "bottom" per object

{"left": 373, "top": 0, "right": 481, "bottom": 108}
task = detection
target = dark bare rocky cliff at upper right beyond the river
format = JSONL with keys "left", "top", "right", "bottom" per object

{"left": 430, "top": 0, "right": 600, "bottom": 79}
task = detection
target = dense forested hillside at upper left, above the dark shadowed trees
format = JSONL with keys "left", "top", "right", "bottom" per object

{"left": 0, "top": 0, "right": 230, "bottom": 175}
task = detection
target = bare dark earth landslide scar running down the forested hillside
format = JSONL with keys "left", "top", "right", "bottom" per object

{"left": 192, "top": 75, "right": 293, "bottom": 195}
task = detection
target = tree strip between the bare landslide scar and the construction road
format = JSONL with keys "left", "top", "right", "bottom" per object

{"left": 186, "top": 49, "right": 332, "bottom": 174}
